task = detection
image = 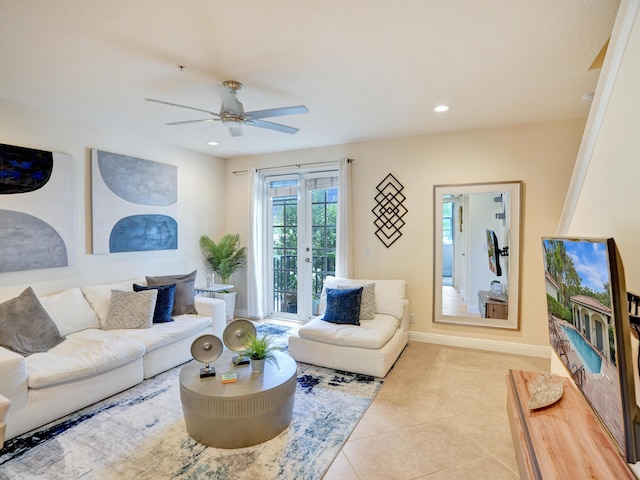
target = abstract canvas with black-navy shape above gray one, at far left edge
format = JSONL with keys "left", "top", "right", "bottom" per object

{"left": 0, "top": 144, "right": 74, "bottom": 272}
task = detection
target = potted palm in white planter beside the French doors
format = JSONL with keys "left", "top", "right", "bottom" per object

{"left": 199, "top": 233, "right": 247, "bottom": 323}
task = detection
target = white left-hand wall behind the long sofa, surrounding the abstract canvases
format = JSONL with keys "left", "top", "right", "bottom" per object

{"left": 0, "top": 100, "right": 224, "bottom": 300}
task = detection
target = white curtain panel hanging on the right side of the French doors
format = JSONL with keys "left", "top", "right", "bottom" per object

{"left": 336, "top": 158, "right": 353, "bottom": 278}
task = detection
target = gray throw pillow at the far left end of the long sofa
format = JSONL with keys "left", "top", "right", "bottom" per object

{"left": 0, "top": 287, "right": 64, "bottom": 357}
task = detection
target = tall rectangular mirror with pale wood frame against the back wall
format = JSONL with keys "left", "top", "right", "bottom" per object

{"left": 433, "top": 182, "right": 522, "bottom": 330}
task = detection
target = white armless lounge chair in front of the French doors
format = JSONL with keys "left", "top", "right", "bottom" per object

{"left": 289, "top": 276, "right": 409, "bottom": 377}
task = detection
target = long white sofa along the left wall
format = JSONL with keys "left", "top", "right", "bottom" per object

{"left": 0, "top": 278, "right": 226, "bottom": 439}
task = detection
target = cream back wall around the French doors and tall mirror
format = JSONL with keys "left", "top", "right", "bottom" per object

{"left": 225, "top": 120, "right": 584, "bottom": 347}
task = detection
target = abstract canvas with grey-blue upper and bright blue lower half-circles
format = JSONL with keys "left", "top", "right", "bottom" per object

{"left": 91, "top": 149, "right": 178, "bottom": 254}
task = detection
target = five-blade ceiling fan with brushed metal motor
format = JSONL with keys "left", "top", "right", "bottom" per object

{"left": 145, "top": 80, "right": 309, "bottom": 137}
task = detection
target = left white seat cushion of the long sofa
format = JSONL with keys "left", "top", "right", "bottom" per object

{"left": 26, "top": 329, "right": 144, "bottom": 388}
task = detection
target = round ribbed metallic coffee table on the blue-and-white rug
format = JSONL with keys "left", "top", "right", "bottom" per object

{"left": 180, "top": 350, "right": 297, "bottom": 448}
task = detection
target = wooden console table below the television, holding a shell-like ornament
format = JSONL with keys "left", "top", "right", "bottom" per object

{"left": 507, "top": 370, "right": 636, "bottom": 480}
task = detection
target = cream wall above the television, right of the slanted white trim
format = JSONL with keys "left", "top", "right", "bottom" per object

{"left": 560, "top": 5, "right": 640, "bottom": 292}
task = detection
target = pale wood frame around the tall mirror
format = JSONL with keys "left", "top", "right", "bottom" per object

{"left": 433, "top": 181, "right": 523, "bottom": 330}
